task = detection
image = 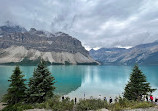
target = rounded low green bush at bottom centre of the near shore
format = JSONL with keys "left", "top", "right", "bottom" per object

{"left": 76, "top": 99, "right": 108, "bottom": 111}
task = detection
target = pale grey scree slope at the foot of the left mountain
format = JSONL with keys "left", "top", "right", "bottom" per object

{"left": 0, "top": 46, "right": 96, "bottom": 64}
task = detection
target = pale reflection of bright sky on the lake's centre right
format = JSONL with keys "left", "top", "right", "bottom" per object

{"left": 68, "top": 66, "right": 131, "bottom": 98}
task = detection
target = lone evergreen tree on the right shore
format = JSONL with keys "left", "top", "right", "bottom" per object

{"left": 124, "top": 65, "right": 156, "bottom": 101}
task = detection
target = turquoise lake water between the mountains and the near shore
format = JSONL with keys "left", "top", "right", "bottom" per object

{"left": 0, "top": 65, "right": 158, "bottom": 98}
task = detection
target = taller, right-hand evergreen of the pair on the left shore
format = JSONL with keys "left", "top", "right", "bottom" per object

{"left": 28, "top": 60, "right": 55, "bottom": 103}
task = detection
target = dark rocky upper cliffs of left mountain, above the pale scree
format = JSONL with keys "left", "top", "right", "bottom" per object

{"left": 0, "top": 26, "right": 89, "bottom": 56}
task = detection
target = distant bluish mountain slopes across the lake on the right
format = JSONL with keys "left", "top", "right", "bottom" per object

{"left": 89, "top": 41, "right": 158, "bottom": 65}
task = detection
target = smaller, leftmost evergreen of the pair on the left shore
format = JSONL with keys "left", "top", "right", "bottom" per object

{"left": 2, "top": 66, "right": 26, "bottom": 105}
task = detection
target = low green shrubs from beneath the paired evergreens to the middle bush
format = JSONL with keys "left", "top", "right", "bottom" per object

{"left": 2, "top": 96, "right": 74, "bottom": 111}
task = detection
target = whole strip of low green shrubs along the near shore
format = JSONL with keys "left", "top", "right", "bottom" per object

{"left": 2, "top": 96, "right": 155, "bottom": 111}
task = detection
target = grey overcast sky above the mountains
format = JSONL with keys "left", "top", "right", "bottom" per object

{"left": 0, "top": 0, "right": 158, "bottom": 48}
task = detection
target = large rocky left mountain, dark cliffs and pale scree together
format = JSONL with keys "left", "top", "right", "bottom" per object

{"left": 0, "top": 25, "right": 98, "bottom": 64}
